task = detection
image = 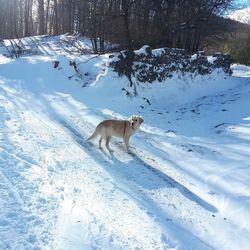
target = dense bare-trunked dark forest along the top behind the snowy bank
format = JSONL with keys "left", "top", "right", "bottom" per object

{"left": 0, "top": 0, "right": 238, "bottom": 52}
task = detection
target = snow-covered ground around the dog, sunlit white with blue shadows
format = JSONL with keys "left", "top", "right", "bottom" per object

{"left": 0, "top": 37, "right": 250, "bottom": 250}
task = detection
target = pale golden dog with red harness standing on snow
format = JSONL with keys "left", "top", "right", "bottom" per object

{"left": 87, "top": 115, "right": 144, "bottom": 152}
